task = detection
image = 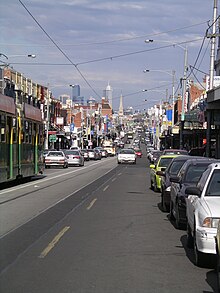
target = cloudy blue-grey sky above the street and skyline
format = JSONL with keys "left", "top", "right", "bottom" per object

{"left": 0, "top": 0, "right": 217, "bottom": 110}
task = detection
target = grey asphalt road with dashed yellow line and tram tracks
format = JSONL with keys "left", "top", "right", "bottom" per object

{"left": 0, "top": 149, "right": 216, "bottom": 293}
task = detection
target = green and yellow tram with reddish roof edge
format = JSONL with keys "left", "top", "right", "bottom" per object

{"left": 0, "top": 94, "right": 44, "bottom": 183}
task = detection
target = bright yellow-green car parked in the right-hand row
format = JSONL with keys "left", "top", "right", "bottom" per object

{"left": 150, "top": 155, "right": 178, "bottom": 192}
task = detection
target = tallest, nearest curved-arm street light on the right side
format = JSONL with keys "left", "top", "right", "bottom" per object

{"left": 145, "top": 40, "right": 188, "bottom": 149}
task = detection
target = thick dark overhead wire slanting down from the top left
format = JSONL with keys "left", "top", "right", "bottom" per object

{"left": 19, "top": 0, "right": 101, "bottom": 99}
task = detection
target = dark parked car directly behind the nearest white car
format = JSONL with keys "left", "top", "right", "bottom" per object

{"left": 170, "top": 157, "right": 217, "bottom": 229}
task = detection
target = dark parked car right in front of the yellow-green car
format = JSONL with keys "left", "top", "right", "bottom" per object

{"left": 157, "top": 155, "right": 192, "bottom": 212}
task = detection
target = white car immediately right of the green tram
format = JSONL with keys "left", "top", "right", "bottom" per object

{"left": 44, "top": 151, "right": 68, "bottom": 168}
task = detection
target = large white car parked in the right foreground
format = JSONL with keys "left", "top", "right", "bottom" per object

{"left": 185, "top": 163, "right": 220, "bottom": 266}
